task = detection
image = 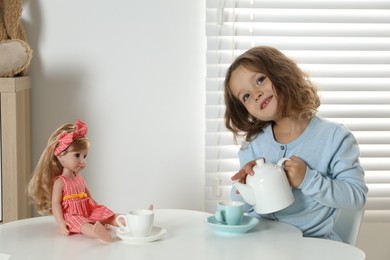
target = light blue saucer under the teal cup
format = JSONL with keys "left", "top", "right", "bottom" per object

{"left": 206, "top": 215, "right": 259, "bottom": 234}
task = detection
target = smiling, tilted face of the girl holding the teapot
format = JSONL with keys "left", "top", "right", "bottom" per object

{"left": 229, "top": 66, "right": 278, "bottom": 121}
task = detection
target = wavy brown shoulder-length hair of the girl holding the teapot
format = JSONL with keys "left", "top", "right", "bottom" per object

{"left": 224, "top": 46, "right": 321, "bottom": 141}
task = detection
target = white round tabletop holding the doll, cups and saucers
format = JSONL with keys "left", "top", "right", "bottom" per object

{"left": 0, "top": 209, "right": 365, "bottom": 260}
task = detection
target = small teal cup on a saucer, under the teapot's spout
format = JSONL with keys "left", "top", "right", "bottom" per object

{"left": 214, "top": 201, "right": 244, "bottom": 225}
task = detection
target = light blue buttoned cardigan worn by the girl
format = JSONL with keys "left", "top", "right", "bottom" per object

{"left": 231, "top": 117, "right": 368, "bottom": 240}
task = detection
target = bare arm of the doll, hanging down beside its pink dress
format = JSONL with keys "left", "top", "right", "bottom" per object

{"left": 51, "top": 179, "right": 69, "bottom": 236}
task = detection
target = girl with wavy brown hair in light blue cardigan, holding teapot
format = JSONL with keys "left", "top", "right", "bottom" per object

{"left": 225, "top": 46, "right": 368, "bottom": 240}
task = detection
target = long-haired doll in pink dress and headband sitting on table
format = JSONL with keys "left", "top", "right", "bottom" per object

{"left": 28, "top": 120, "right": 117, "bottom": 242}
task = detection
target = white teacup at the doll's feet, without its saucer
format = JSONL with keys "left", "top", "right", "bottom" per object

{"left": 116, "top": 209, "right": 154, "bottom": 237}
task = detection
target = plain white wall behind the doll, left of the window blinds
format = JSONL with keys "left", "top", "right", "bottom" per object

{"left": 23, "top": 0, "right": 206, "bottom": 212}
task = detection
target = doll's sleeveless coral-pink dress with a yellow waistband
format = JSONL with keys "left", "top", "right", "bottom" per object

{"left": 57, "top": 175, "right": 114, "bottom": 233}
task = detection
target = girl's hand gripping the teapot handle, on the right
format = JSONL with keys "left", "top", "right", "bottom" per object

{"left": 284, "top": 156, "right": 307, "bottom": 188}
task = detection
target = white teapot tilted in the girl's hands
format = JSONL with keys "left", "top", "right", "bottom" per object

{"left": 233, "top": 158, "right": 294, "bottom": 214}
